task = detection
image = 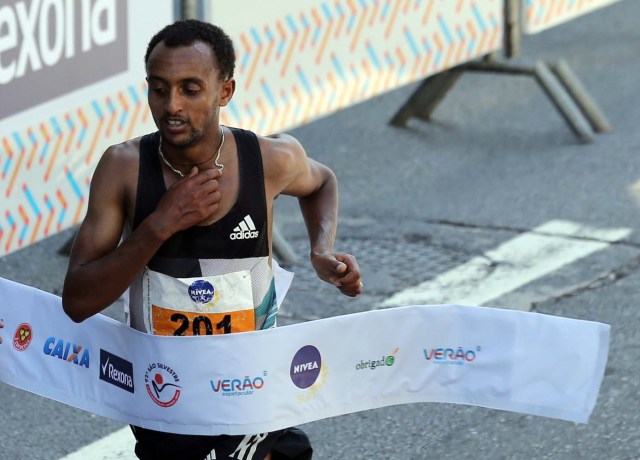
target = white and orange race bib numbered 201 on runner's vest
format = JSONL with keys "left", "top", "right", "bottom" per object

{"left": 143, "top": 268, "right": 255, "bottom": 335}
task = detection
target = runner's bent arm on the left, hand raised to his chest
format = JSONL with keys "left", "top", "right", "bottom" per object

{"left": 62, "top": 142, "right": 220, "bottom": 322}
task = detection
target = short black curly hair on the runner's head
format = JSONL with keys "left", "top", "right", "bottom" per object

{"left": 144, "top": 19, "right": 236, "bottom": 81}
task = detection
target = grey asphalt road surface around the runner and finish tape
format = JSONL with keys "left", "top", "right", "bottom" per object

{"left": 0, "top": 0, "right": 640, "bottom": 460}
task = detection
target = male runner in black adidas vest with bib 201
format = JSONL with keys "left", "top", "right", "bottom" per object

{"left": 62, "top": 20, "right": 362, "bottom": 460}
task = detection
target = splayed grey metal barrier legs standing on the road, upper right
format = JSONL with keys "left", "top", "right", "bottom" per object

{"left": 390, "top": 58, "right": 611, "bottom": 143}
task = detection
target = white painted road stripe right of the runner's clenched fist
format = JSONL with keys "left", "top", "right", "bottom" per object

{"left": 378, "top": 220, "right": 631, "bottom": 308}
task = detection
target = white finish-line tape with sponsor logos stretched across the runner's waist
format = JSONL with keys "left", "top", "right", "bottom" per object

{"left": 0, "top": 278, "right": 610, "bottom": 435}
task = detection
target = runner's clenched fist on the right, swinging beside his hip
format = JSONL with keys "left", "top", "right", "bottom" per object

{"left": 311, "top": 253, "right": 364, "bottom": 297}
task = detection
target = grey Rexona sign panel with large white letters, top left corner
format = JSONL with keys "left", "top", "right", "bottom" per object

{"left": 0, "top": 0, "right": 128, "bottom": 119}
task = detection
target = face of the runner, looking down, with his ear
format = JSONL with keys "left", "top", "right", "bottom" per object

{"left": 147, "top": 42, "right": 233, "bottom": 147}
